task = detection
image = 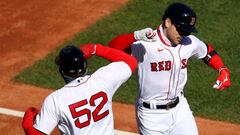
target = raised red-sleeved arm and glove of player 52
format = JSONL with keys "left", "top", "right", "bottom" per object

{"left": 80, "top": 44, "right": 137, "bottom": 72}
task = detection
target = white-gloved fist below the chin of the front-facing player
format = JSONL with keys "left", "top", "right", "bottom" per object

{"left": 134, "top": 28, "right": 156, "bottom": 42}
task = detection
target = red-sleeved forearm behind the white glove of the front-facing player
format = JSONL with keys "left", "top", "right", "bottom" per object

{"left": 108, "top": 33, "right": 136, "bottom": 51}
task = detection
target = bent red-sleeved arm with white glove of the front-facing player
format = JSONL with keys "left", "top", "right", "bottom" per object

{"left": 108, "top": 28, "right": 156, "bottom": 52}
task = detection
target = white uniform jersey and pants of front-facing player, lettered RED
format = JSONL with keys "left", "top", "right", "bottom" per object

{"left": 131, "top": 25, "right": 207, "bottom": 135}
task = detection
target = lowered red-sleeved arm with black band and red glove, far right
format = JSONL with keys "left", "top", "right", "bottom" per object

{"left": 204, "top": 44, "right": 231, "bottom": 90}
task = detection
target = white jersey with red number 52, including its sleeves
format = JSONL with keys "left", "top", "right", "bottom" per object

{"left": 34, "top": 62, "right": 132, "bottom": 135}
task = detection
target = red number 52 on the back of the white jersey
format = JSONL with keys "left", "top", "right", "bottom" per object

{"left": 69, "top": 92, "right": 109, "bottom": 128}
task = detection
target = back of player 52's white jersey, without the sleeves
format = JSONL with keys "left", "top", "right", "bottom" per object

{"left": 54, "top": 76, "right": 113, "bottom": 135}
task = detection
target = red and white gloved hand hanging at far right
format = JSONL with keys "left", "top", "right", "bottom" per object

{"left": 213, "top": 68, "right": 231, "bottom": 90}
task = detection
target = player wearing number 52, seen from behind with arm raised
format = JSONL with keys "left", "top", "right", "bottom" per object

{"left": 22, "top": 44, "right": 137, "bottom": 135}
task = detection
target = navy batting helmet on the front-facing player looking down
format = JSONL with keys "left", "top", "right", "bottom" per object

{"left": 162, "top": 3, "right": 197, "bottom": 33}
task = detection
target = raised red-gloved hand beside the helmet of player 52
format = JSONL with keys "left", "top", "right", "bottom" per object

{"left": 80, "top": 44, "right": 96, "bottom": 59}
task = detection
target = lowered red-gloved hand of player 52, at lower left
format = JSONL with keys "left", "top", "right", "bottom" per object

{"left": 22, "top": 107, "right": 38, "bottom": 130}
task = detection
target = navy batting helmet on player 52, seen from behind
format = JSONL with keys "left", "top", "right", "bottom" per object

{"left": 55, "top": 45, "right": 87, "bottom": 83}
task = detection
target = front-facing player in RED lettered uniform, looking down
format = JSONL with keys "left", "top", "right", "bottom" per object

{"left": 109, "top": 3, "right": 231, "bottom": 135}
